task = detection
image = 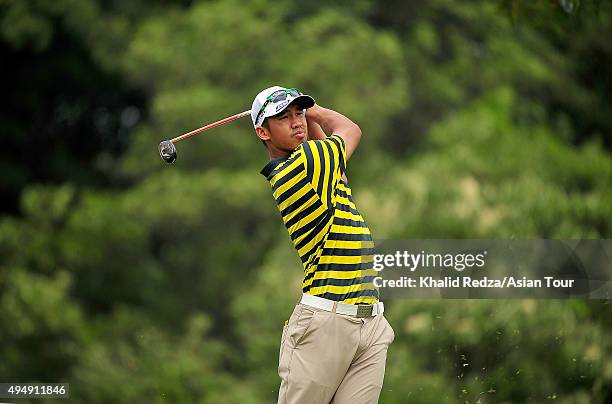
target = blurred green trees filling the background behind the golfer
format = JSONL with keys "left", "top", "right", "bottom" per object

{"left": 0, "top": 0, "right": 612, "bottom": 403}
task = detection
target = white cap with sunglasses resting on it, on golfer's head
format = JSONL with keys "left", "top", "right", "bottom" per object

{"left": 251, "top": 86, "right": 315, "bottom": 127}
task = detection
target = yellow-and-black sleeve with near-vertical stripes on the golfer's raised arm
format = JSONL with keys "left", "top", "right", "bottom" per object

{"left": 302, "top": 135, "right": 346, "bottom": 208}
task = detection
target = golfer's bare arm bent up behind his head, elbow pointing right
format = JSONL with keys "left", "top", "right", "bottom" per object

{"left": 306, "top": 105, "right": 361, "bottom": 161}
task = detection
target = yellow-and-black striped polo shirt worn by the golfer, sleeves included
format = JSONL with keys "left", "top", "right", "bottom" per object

{"left": 261, "top": 135, "right": 378, "bottom": 304}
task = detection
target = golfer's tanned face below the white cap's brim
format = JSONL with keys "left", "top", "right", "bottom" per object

{"left": 256, "top": 104, "right": 307, "bottom": 157}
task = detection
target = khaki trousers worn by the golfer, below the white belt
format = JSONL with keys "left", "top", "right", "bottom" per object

{"left": 278, "top": 304, "right": 395, "bottom": 404}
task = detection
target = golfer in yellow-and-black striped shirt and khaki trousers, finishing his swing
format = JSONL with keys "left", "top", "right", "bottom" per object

{"left": 251, "top": 86, "right": 395, "bottom": 404}
